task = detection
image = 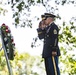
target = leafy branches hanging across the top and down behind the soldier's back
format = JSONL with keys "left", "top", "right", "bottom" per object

{"left": 0, "top": 0, "right": 76, "bottom": 75}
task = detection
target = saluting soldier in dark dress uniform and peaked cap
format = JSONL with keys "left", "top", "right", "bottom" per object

{"left": 37, "top": 13, "right": 60, "bottom": 75}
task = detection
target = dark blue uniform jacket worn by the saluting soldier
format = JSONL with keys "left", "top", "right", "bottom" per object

{"left": 37, "top": 23, "right": 60, "bottom": 58}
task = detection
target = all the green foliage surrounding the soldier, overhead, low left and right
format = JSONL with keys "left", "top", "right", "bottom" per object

{"left": 0, "top": 0, "right": 76, "bottom": 75}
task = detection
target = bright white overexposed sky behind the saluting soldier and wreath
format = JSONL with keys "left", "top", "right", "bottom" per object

{"left": 0, "top": 0, "right": 76, "bottom": 55}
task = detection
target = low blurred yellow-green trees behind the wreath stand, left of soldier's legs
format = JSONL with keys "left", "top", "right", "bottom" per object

{"left": 0, "top": 51, "right": 45, "bottom": 75}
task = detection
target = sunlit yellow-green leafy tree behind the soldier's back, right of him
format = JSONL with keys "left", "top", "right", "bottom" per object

{"left": 59, "top": 22, "right": 76, "bottom": 75}
